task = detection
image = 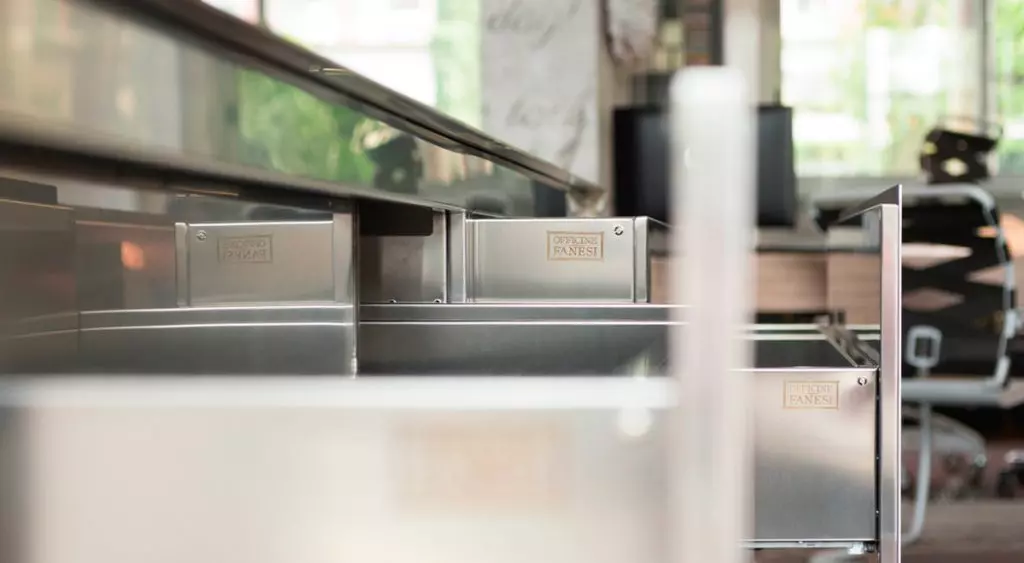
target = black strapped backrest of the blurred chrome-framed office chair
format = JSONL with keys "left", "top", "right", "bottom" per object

{"left": 813, "top": 184, "right": 1018, "bottom": 386}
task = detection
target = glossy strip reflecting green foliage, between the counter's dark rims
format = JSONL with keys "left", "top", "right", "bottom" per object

{"left": 0, "top": 0, "right": 552, "bottom": 215}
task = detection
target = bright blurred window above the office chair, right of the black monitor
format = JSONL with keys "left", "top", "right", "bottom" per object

{"left": 781, "top": 0, "right": 987, "bottom": 176}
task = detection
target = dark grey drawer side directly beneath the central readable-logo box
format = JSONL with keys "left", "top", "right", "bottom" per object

{"left": 359, "top": 304, "right": 864, "bottom": 375}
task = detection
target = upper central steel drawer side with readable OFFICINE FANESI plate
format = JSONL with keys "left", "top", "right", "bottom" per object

{"left": 470, "top": 218, "right": 637, "bottom": 302}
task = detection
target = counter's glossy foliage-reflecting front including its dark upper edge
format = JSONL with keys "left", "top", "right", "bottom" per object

{"left": 0, "top": 0, "right": 597, "bottom": 216}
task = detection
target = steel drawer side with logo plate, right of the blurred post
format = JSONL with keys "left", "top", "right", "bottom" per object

{"left": 754, "top": 369, "right": 877, "bottom": 542}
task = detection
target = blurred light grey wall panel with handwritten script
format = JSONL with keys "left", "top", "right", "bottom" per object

{"left": 481, "top": 0, "right": 605, "bottom": 182}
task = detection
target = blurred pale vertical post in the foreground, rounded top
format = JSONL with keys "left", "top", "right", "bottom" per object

{"left": 669, "top": 67, "right": 756, "bottom": 563}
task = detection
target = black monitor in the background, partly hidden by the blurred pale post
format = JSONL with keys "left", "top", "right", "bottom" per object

{"left": 614, "top": 105, "right": 797, "bottom": 226}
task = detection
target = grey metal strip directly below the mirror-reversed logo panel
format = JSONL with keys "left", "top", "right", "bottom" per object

{"left": 80, "top": 305, "right": 355, "bottom": 375}
